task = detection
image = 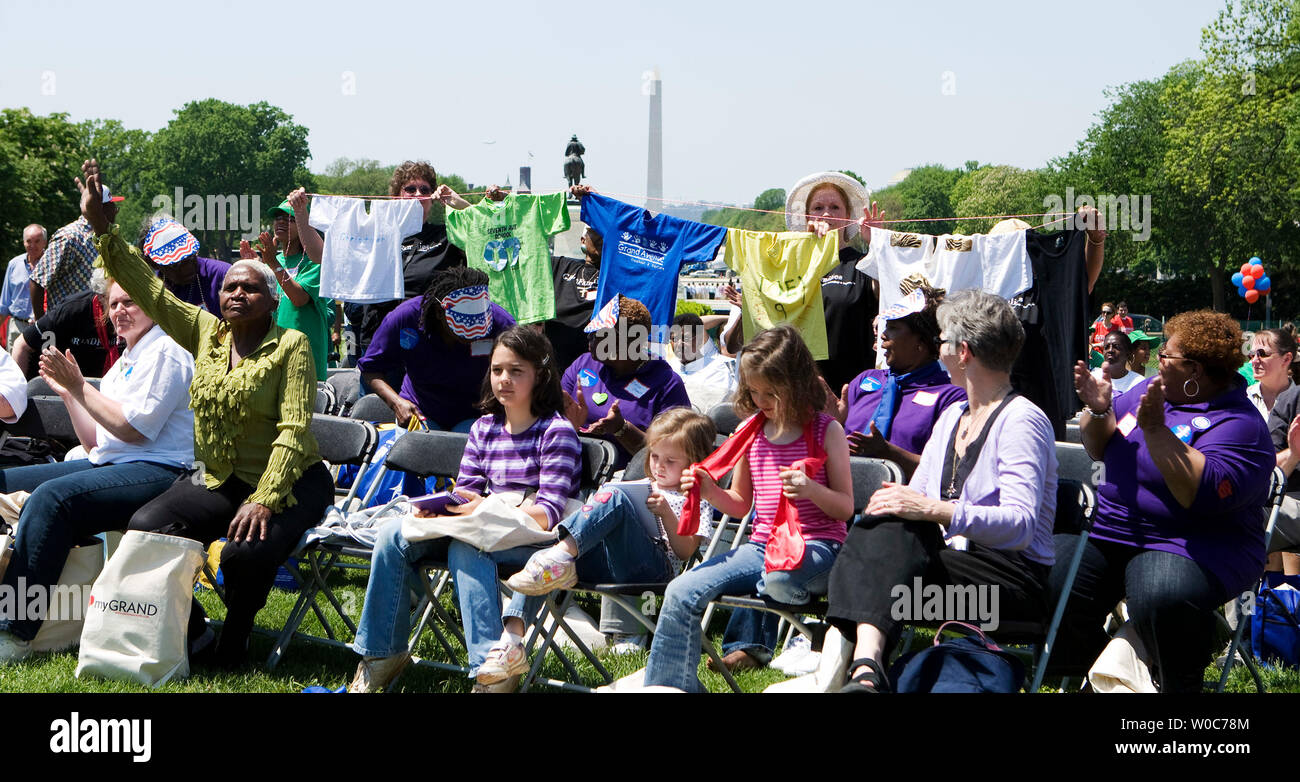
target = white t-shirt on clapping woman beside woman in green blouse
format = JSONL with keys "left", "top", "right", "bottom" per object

{"left": 88, "top": 320, "right": 194, "bottom": 468}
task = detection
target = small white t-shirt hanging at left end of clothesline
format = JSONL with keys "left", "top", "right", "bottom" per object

{"left": 308, "top": 196, "right": 424, "bottom": 304}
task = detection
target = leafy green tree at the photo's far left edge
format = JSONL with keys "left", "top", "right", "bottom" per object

{"left": 0, "top": 108, "right": 86, "bottom": 248}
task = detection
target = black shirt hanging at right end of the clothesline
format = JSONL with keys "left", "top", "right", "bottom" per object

{"left": 1011, "top": 230, "right": 1092, "bottom": 440}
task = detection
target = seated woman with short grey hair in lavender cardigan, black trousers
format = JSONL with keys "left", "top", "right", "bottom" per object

{"left": 818, "top": 290, "right": 1057, "bottom": 692}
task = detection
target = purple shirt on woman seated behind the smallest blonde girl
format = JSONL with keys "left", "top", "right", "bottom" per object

{"left": 560, "top": 353, "right": 696, "bottom": 469}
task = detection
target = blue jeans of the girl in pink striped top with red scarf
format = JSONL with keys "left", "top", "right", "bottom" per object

{"left": 645, "top": 540, "right": 840, "bottom": 692}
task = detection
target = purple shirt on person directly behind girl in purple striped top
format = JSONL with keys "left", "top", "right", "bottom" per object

{"left": 356, "top": 296, "right": 517, "bottom": 429}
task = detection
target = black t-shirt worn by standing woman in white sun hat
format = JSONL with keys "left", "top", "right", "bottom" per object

{"left": 816, "top": 247, "right": 880, "bottom": 394}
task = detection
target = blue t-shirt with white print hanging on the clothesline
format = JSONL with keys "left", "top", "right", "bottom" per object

{"left": 582, "top": 192, "right": 727, "bottom": 331}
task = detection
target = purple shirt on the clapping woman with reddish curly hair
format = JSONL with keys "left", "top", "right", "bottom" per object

{"left": 1092, "top": 378, "right": 1277, "bottom": 596}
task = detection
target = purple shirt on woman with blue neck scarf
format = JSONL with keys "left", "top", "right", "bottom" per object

{"left": 844, "top": 369, "right": 966, "bottom": 453}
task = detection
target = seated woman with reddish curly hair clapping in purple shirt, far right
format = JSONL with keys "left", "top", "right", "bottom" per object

{"left": 1052, "top": 310, "right": 1275, "bottom": 692}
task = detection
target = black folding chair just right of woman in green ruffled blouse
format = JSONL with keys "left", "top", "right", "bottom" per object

{"left": 265, "top": 414, "right": 378, "bottom": 669}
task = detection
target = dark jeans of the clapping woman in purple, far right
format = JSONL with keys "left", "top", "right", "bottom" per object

{"left": 1049, "top": 535, "right": 1231, "bottom": 692}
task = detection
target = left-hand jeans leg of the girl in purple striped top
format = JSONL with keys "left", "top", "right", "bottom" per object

{"left": 352, "top": 518, "right": 449, "bottom": 657}
